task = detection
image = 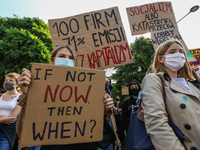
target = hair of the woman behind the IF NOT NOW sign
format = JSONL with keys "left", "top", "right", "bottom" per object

{"left": 51, "top": 45, "right": 76, "bottom": 64}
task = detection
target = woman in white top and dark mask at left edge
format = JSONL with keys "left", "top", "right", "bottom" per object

{"left": 0, "top": 73, "right": 21, "bottom": 150}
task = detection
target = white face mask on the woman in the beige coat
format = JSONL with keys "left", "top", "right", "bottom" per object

{"left": 164, "top": 52, "right": 185, "bottom": 71}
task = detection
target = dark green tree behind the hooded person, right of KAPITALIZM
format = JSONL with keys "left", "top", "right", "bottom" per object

{"left": 111, "top": 37, "right": 154, "bottom": 99}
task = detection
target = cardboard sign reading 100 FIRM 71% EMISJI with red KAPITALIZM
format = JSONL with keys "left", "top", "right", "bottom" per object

{"left": 49, "top": 7, "right": 133, "bottom": 69}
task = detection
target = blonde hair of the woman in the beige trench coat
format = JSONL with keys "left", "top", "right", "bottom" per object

{"left": 153, "top": 39, "right": 194, "bottom": 80}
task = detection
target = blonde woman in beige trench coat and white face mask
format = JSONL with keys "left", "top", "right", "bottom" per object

{"left": 142, "top": 40, "right": 200, "bottom": 150}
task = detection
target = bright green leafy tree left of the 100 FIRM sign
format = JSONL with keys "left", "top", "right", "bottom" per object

{"left": 0, "top": 17, "right": 53, "bottom": 91}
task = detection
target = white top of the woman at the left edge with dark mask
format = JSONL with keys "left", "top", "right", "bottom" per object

{"left": 0, "top": 93, "right": 20, "bottom": 116}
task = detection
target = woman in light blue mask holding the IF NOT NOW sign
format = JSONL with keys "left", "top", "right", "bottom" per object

{"left": 17, "top": 45, "right": 114, "bottom": 150}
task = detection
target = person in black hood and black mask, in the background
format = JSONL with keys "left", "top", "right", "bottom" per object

{"left": 122, "top": 80, "right": 141, "bottom": 133}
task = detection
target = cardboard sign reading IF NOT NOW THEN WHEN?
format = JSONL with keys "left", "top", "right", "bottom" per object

{"left": 20, "top": 63, "right": 105, "bottom": 147}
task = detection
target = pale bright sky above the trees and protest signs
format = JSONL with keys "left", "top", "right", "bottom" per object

{"left": 0, "top": 0, "right": 200, "bottom": 49}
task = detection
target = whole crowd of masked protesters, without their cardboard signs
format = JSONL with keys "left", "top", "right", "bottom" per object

{"left": 0, "top": 39, "right": 200, "bottom": 150}
